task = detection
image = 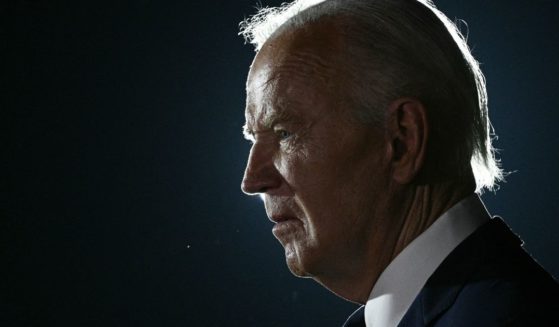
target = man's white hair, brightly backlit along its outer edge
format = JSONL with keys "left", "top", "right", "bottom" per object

{"left": 239, "top": 0, "right": 503, "bottom": 193}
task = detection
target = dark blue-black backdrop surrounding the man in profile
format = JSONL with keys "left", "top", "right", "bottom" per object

{"left": 0, "top": 0, "right": 559, "bottom": 326}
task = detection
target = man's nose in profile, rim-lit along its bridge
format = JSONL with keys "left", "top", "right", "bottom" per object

{"left": 241, "top": 143, "right": 282, "bottom": 195}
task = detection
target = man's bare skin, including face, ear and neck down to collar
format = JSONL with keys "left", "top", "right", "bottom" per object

{"left": 242, "top": 18, "right": 475, "bottom": 303}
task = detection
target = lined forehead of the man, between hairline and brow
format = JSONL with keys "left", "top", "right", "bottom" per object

{"left": 246, "top": 22, "right": 343, "bottom": 127}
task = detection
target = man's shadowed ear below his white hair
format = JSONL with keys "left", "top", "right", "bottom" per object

{"left": 386, "top": 98, "right": 429, "bottom": 184}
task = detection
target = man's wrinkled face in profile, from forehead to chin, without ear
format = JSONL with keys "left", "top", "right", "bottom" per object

{"left": 242, "top": 24, "right": 396, "bottom": 277}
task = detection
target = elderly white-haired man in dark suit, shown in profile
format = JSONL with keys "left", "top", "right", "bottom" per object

{"left": 242, "top": 0, "right": 559, "bottom": 326}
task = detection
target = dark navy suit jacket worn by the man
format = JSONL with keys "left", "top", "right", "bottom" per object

{"left": 344, "top": 218, "right": 559, "bottom": 327}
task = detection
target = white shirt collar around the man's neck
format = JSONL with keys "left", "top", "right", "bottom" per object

{"left": 365, "top": 194, "right": 490, "bottom": 327}
